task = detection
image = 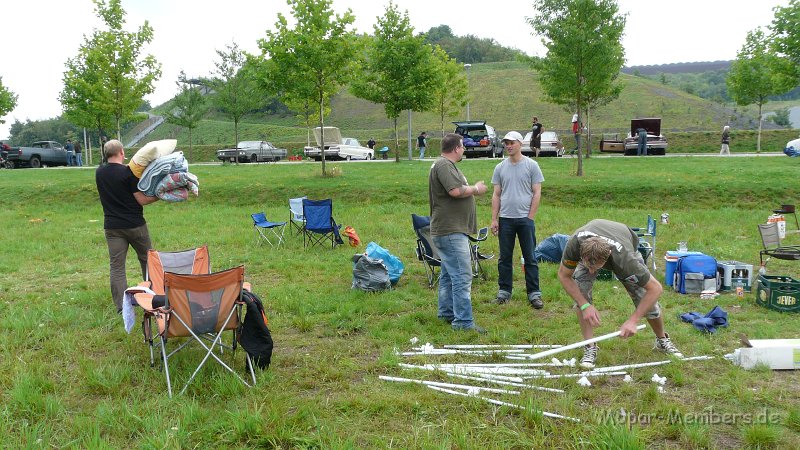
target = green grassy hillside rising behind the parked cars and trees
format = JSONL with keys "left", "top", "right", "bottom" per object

{"left": 136, "top": 62, "right": 780, "bottom": 154}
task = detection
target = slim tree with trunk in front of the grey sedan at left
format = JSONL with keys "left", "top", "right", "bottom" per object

{"left": 210, "top": 42, "right": 265, "bottom": 154}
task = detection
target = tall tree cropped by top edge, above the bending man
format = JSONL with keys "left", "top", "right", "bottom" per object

{"left": 527, "top": 0, "right": 625, "bottom": 176}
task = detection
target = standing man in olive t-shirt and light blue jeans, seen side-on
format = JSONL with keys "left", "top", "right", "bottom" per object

{"left": 428, "top": 133, "right": 486, "bottom": 333}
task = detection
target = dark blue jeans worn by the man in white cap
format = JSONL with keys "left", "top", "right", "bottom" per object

{"left": 497, "top": 217, "right": 541, "bottom": 298}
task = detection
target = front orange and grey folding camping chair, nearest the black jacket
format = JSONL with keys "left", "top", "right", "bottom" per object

{"left": 135, "top": 266, "right": 256, "bottom": 397}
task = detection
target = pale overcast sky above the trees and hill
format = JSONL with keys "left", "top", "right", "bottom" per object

{"left": 0, "top": 0, "right": 788, "bottom": 138}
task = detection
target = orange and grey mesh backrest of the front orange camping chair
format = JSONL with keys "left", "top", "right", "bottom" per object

{"left": 164, "top": 266, "right": 244, "bottom": 336}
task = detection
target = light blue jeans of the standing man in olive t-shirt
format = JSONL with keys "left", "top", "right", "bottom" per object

{"left": 431, "top": 233, "right": 475, "bottom": 328}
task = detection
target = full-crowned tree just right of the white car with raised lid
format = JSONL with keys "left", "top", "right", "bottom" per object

{"left": 351, "top": 1, "right": 442, "bottom": 161}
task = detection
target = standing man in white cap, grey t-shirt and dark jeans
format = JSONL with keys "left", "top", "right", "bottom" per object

{"left": 492, "top": 131, "right": 544, "bottom": 309}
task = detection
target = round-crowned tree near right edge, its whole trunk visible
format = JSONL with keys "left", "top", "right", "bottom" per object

{"left": 727, "top": 28, "right": 794, "bottom": 153}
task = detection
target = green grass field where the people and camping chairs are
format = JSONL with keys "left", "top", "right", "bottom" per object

{"left": 0, "top": 157, "right": 800, "bottom": 449}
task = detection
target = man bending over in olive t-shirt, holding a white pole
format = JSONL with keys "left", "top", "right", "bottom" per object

{"left": 558, "top": 219, "right": 683, "bottom": 368}
